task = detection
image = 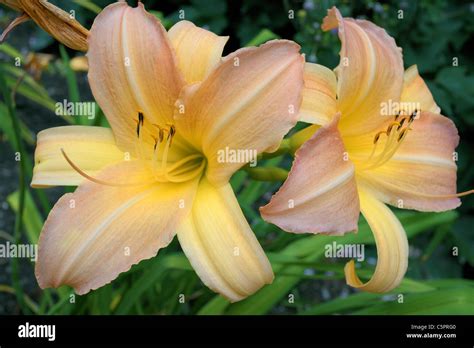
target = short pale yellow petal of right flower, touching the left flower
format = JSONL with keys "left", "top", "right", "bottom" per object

{"left": 300, "top": 63, "right": 337, "bottom": 125}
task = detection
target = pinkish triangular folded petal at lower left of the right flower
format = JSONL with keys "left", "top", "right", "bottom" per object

{"left": 260, "top": 116, "right": 359, "bottom": 235}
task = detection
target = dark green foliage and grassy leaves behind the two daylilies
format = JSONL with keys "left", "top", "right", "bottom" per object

{"left": 0, "top": 0, "right": 474, "bottom": 314}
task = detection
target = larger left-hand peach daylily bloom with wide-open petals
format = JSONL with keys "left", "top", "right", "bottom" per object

{"left": 32, "top": 2, "right": 304, "bottom": 301}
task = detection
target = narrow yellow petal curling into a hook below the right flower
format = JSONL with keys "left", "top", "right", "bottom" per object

{"left": 344, "top": 188, "right": 408, "bottom": 293}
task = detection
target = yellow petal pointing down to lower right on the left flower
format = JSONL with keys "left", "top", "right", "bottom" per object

{"left": 177, "top": 179, "right": 273, "bottom": 302}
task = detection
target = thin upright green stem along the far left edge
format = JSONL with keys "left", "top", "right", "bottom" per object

{"left": 0, "top": 74, "right": 30, "bottom": 313}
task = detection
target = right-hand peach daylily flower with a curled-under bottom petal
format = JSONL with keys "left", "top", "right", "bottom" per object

{"left": 261, "top": 8, "right": 470, "bottom": 293}
